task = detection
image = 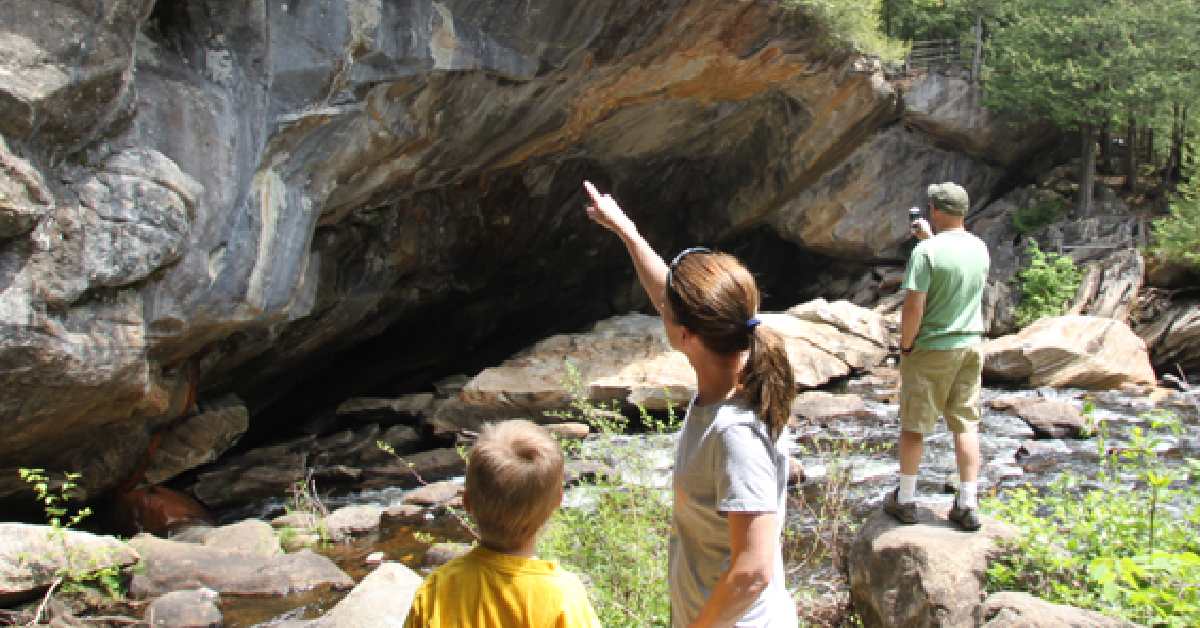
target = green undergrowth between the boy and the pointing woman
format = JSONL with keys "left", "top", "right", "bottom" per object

{"left": 539, "top": 363, "right": 678, "bottom": 626}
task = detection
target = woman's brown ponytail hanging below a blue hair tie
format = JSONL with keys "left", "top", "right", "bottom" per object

{"left": 742, "top": 324, "right": 796, "bottom": 441}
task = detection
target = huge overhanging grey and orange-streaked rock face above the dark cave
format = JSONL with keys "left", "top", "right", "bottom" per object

{"left": 0, "top": 0, "right": 1171, "bottom": 497}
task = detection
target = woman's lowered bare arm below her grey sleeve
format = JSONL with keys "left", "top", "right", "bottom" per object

{"left": 691, "top": 513, "right": 779, "bottom": 628}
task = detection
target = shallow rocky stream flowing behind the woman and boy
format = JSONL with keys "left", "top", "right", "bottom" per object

{"left": 222, "top": 382, "right": 1200, "bottom": 627}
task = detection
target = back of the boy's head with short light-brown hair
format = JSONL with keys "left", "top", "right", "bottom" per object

{"left": 467, "top": 420, "right": 563, "bottom": 551}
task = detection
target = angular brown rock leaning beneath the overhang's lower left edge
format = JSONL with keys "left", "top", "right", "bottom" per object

{"left": 145, "top": 395, "right": 250, "bottom": 484}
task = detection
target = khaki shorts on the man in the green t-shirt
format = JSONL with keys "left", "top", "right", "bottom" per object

{"left": 900, "top": 346, "right": 983, "bottom": 433}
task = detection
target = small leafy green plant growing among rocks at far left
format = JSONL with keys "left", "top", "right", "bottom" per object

{"left": 17, "top": 468, "right": 125, "bottom": 599}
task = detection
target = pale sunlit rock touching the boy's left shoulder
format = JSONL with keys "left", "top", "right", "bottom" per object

{"left": 308, "top": 562, "right": 422, "bottom": 628}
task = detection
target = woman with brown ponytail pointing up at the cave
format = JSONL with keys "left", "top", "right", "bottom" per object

{"left": 583, "top": 181, "right": 797, "bottom": 628}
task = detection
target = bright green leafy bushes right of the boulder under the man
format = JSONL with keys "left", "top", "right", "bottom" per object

{"left": 983, "top": 413, "right": 1200, "bottom": 627}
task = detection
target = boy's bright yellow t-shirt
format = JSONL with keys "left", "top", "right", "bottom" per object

{"left": 404, "top": 545, "right": 600, "bottom": 628}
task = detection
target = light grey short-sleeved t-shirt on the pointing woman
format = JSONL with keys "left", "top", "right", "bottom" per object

{"left": 667, "top": 400, "right": 797, "bottom": 628}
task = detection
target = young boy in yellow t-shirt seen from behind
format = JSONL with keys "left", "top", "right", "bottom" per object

{"left": 404, "top": 420, "right": 600, "bottom": 628}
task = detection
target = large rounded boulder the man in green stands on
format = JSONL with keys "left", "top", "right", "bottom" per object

{"left": 847, "top": 507, "right": 1016, "bottom": 628}
